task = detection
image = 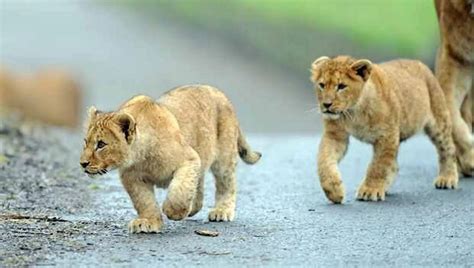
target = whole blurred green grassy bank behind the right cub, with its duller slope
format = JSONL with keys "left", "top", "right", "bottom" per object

{"left": 124, "top": 0, "right": 438, "bottom": 75}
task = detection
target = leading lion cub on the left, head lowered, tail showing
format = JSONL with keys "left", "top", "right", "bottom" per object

{"left": 80, "top": 85, "right": 261, "bottom": 233}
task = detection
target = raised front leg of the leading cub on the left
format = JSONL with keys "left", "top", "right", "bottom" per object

{"left": 163, "top": 152, "right": 202, "bottom": 221}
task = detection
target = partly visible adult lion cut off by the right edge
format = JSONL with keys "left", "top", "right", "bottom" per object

{"left": 435, "top": 0, "right": 474, "bottom": 176}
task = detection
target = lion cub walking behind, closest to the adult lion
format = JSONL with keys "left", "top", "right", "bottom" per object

{"left": 311, "top": 56, "right": 458, "bottom": 203}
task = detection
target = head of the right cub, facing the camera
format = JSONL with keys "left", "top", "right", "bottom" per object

{"left": 311, "top": 56, "right": 372, "bottom": 120}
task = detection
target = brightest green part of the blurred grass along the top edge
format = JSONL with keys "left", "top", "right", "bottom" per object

{"left": 162, "top": 0, "right": 438, "bottom": 55}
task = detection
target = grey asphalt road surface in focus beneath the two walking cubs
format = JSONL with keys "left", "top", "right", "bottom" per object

{"left": 48, "top": 136, "right": 474, "bottom": 267}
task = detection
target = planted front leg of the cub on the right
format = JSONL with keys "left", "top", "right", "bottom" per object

{"left": 357, "top": 134, "right": 400, "bottom": 201}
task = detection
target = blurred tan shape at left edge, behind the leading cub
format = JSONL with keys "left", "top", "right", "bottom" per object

{"left": 0, "top": 68, "right": 81, "bottom": 127}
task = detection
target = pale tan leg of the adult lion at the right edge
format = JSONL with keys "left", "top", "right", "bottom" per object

{"left": 436, "top": 53, "right": 474, "bottom": 176}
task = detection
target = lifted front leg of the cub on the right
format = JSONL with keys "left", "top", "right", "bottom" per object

{"left": 318, "top": 123, "right": 349, "bottom": 204}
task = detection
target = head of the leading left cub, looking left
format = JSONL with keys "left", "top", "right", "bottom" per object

{"left": 80, "top": 107, "right": 136, "bottom": 175}
